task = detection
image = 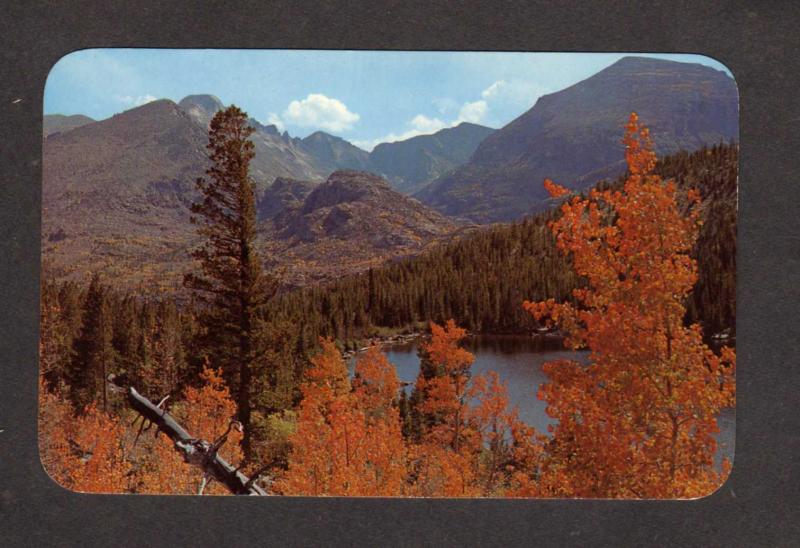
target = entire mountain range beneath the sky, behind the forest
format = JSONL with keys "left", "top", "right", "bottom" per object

{"left": 42, "top": 57, "right": 738, "bottom": 285}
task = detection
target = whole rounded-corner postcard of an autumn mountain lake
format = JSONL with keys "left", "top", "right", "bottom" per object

{"left": 39, "top": 49, "right": 739, "bottom": 499}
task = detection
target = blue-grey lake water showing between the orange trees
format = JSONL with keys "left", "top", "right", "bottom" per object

{"left": 351, "top": 335, "right": 736, "bottom": 463}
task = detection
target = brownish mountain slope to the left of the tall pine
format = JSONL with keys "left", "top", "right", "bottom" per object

{"left": 42, "top": 100, "right": 207, "bottom": 286}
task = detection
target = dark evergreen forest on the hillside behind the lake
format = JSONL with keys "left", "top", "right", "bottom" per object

{"left": 272, "top": 144, "right": 738, "bottom": 346}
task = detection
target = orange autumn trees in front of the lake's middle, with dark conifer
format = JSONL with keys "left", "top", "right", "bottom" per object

{"left": 408, "top": 320, "right": 538, "bottom": 497}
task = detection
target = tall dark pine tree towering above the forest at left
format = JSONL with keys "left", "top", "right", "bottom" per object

{"left": 184, "top": 106, "right": 277, "bottom": 457}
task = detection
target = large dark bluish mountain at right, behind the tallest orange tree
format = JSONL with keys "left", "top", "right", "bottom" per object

{"left": 417, "top": 57, "right": 738, "bottom": 222}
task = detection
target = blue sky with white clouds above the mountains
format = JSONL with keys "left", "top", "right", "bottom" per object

{"left": 44, "top": 49, "right": 730, "bottom": 150}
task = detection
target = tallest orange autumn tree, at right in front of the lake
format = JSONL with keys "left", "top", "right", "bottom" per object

{"left": 524, "top": 114, "right": 735, "bottom": 498}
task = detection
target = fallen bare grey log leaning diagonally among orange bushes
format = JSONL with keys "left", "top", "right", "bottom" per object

{"left": 108, "top": 376, "right": 268, "bottom": 496}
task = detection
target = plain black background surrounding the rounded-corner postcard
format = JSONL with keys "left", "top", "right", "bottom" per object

{"left": 0, "top": 0, "right": 800, "bottom": 546}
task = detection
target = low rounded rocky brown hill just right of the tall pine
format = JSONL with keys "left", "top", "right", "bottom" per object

{"left": 264, "top": 170, "right": 458, "bottom": 285}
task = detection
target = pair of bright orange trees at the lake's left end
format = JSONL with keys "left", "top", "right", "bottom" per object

{"left": 275, "top": 339, "right": 405, "bottom": 496}
